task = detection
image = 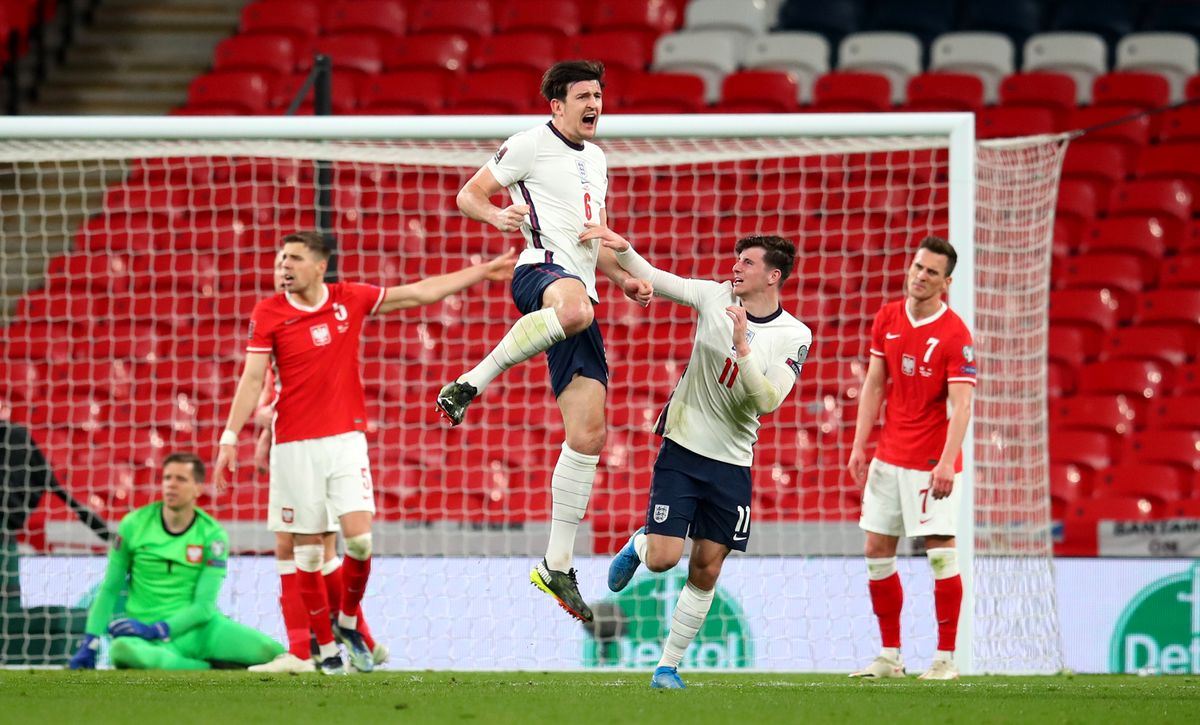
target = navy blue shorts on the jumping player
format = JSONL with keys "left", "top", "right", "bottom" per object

{"left": 512, "top": 264, "right": 608, "bottom": 397}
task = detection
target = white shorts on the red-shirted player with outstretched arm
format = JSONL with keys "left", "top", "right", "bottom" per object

{"left": 266, "top": 432, "right": 374, "bottom": 534}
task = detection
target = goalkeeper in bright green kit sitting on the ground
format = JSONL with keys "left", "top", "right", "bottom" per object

{"left": 70, "top": 453, "right": 283, "bottom": 670}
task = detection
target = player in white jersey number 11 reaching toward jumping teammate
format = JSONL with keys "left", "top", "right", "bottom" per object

{"left": 583, "top": 227, "right": 812, "bottom": 689}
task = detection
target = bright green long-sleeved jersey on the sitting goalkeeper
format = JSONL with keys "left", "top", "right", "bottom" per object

{"left": 86, "top": 502, "right": 229, "bottom": 636}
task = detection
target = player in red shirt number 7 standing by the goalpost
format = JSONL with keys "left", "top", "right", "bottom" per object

{"left": 847, "top": 236, "right": 976, "bottom": 679}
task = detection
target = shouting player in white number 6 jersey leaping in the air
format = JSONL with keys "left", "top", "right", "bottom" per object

{"left": 436, "top": 60, "right": 653, "bottom": 622}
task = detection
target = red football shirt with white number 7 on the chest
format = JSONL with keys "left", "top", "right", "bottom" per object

{"left": 871, "top": 300, "right": 976, "bottom": 473}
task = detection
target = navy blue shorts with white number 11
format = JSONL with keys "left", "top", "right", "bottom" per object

{"left": 646, "top": 438, "right": 750, "bottom": 551}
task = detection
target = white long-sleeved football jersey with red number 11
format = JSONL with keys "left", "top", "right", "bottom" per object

{"left": 618, "top": 250, "right": 812, "bottom": 466}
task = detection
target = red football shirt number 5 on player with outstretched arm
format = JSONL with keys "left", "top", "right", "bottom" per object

{"left": 246, "top": 282, "right": 384, "bottom": 443}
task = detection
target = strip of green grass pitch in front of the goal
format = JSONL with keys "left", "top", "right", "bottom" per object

{"left": 0, "top": 670, "right": 1200, "bottom": 725}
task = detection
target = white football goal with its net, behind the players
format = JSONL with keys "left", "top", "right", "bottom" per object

{"left": 0, "top": 113, "right": 1066, "bottom": 672}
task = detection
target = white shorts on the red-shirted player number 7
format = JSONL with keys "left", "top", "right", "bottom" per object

{"left": 858, "top": 459, "right": 962, "bottom": 537}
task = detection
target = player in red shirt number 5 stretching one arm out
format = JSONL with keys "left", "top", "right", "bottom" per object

{"left": 214, "top": 232, "right": 516, "bottom": 675}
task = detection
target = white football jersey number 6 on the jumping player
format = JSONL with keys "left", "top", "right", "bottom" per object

{"left": 487, "top": 122, "right": 608, "bottom": 301}
